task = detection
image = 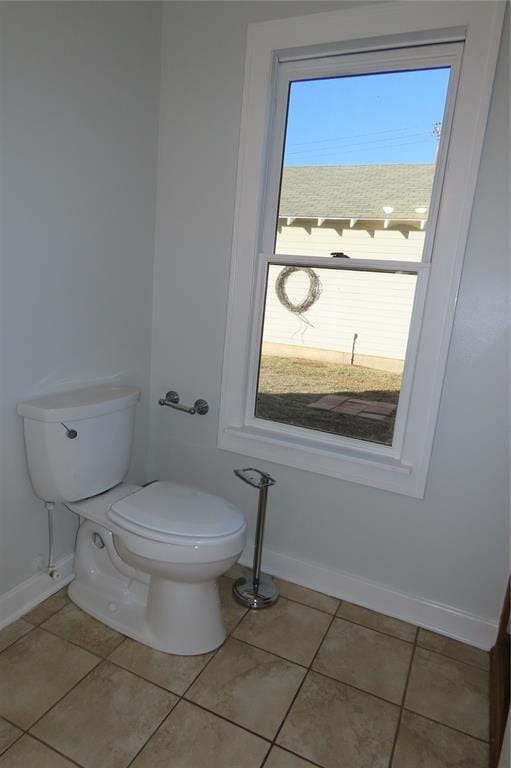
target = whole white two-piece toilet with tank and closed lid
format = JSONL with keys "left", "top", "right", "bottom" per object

{"left": 18, "top": 385, "right": 246, "bottom": 655}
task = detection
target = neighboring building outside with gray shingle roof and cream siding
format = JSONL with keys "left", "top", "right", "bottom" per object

{"left": 263, "top": 164, "right": 434, "bottom": 372}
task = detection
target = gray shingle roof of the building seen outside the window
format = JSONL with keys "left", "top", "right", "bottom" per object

{"left": 279, "top": 163, "right": 435, "bottom": 221}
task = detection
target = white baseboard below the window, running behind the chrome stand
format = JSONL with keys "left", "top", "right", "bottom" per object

{"left": 240, "top": 545, "right": 497, "bottom": 651}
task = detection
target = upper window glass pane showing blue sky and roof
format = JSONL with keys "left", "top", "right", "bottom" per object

{"left": 275, "top": 67, "right": 450, "bottom": 261}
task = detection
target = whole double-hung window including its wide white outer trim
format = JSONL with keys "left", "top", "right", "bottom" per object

{"left": 219, "top": 2, "right": 502, "bottom": 496}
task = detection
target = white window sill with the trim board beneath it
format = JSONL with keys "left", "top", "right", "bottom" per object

{"left": 218, "top": 426, "right": 424, "bottom": 498}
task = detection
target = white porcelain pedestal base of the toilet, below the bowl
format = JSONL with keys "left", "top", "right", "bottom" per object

{"left": 68, "top": 521, "right": 226, "bottom": 656}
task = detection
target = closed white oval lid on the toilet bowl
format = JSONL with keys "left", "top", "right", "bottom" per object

{"left": 107, "top": 482, "right": 245, "bottom": 539}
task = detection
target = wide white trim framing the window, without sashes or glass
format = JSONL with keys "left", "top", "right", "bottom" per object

{"left": 218, "top": 0, "right": 505, "bottom": 498}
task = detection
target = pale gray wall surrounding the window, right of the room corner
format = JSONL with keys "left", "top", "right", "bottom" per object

{"left": 151, "top": 3, "right": 508, "bottom": 619}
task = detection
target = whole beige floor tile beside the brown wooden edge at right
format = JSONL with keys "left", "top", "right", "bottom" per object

{"left": 405, "top": 648, "right": 488, "bottom": 739}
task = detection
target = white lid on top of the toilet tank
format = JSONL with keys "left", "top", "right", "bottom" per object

{"left": 17, "top": 384, "right": 140, "bottom": 422}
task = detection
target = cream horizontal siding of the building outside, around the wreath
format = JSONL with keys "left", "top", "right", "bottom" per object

{"left": 264, "top": 226, "right": 424, "bottom": 362}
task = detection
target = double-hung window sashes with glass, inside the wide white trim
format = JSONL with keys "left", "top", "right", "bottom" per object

{"left": 255, "top": 54, "right": 452, "bottom": 445}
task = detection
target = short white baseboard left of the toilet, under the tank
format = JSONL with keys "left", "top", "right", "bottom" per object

{"left": 0, "top": 554, "right": 74, "bottom": 630}
